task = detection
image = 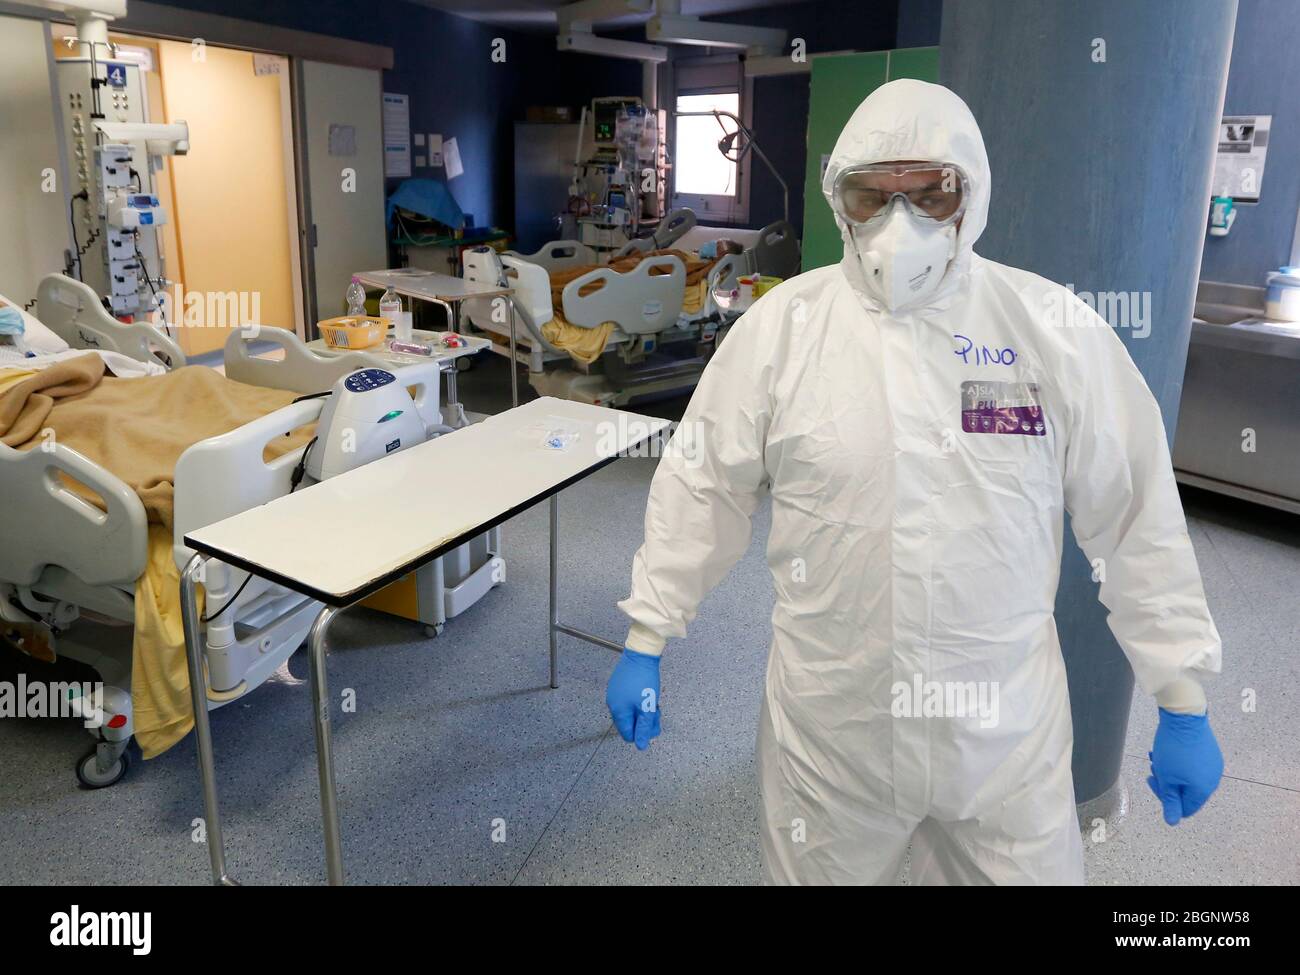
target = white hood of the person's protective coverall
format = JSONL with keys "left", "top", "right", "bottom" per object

{"left": 822, "top": 79, "right": 991, "bottom": 311}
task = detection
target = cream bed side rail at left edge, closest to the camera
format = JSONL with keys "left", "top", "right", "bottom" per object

{"left": 0, "top": 443, "right": 148, "bottom": 586}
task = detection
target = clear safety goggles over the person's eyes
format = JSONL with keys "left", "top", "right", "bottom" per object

{"left": 831, "top": 163, "right": 970, "bottom": 226}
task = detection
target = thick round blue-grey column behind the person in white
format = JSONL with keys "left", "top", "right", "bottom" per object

{"left": 939, "top": 0, "right": 1236, "bottom": 813}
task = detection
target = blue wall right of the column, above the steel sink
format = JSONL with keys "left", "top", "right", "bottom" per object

{"left": 1201, "top": 0, "right": 1300, "bottom": 286}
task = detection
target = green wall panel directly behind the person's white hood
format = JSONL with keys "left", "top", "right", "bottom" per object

{"left": 803, "top": 47, "right": 939, "bottom": 270}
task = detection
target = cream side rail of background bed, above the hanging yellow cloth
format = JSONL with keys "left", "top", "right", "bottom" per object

{"left": 563, "top": 255, "right": 686, "bottom": 335}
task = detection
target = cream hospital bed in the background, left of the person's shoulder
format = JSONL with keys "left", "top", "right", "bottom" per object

{"left": 464, "top": 209, "right": 800, "bottom": 406}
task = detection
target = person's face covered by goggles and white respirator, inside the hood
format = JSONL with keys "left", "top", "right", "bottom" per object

{"left": 833, "top": 163, "right": 970, "bottom": 311}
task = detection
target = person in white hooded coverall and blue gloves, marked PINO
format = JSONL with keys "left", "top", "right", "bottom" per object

{"left": 606, "top": 81, "right": 1222, "bottom": 884}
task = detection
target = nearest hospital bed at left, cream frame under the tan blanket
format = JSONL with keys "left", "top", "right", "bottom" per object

{"left": 0, "top": 274, "right": 488, "bottom": 788}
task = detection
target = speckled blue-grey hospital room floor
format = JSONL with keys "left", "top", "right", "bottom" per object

{"left": 0, "top": 360, "right": 1300, "bottom": 884}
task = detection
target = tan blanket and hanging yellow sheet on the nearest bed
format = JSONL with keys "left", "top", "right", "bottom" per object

{"left": 0, "top": 354, "right": 311, "bottom": 758}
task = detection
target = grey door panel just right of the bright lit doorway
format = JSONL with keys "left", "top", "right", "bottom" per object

{"left": 294, "top": 60, "right": 387, "bottom": 328}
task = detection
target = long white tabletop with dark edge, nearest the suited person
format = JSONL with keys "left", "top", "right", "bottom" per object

{"left": 185, "top": 397, "right": 668, "bottom": 606}
